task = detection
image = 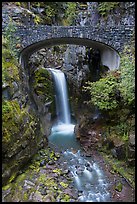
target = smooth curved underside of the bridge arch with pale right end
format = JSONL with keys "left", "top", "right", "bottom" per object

{"left": 20, "top": 37, "right": 120, "bottom": 70}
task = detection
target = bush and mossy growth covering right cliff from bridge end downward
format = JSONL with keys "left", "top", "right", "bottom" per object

{"left": 84, "top": 40, "right": 135, "bottom": 165}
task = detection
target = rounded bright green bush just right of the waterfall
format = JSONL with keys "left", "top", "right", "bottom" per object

{"left": 84, "top": 74, "right": 118, "bottom": 110}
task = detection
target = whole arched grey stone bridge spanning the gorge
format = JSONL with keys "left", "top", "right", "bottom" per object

{"left": 15, "top": 25, "right": 134, "bottom": 69}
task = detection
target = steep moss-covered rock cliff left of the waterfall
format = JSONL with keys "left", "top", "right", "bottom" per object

{"left": 2, "top": 38, "right": 47, "bottom": 185}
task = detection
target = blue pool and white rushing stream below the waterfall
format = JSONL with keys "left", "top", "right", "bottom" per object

{"left": 49, "top": 124, "right": 110, "bottom": 202}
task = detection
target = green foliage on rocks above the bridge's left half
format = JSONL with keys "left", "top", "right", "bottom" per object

{"left": 9, "top": 2, "right": 77, "bottom": 26}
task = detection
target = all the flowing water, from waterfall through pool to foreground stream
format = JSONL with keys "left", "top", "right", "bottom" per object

{"left": 49, "top": 68, "right": 110, "bottom": 202}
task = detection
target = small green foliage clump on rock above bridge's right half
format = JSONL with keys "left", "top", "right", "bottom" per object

{"left": 98, "top": 2, "right": 119, "bottom": 16}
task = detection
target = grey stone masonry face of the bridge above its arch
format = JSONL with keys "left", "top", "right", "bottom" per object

{"left": 10, "top": 25, "right": 134, "bottom": 51}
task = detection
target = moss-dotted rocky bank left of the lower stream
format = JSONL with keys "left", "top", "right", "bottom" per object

{"left": 2, "top": 148, "right": 78, "bottom": 202}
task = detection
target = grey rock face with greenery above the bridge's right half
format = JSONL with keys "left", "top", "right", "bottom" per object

{"left": 76, "top": 2, "right": 135, "bottom": 27}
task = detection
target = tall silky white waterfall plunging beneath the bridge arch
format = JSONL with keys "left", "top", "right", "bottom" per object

{"left": 49, "top": 68, "right": 71, "bottom": 124}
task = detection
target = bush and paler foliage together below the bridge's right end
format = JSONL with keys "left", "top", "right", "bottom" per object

{"left": 84, "top": 43, "right": 135, "bottom": 111}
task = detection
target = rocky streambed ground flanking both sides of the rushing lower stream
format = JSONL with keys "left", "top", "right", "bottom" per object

{"left": 2, "top": 147, "right": 135, "bottom": 202}
